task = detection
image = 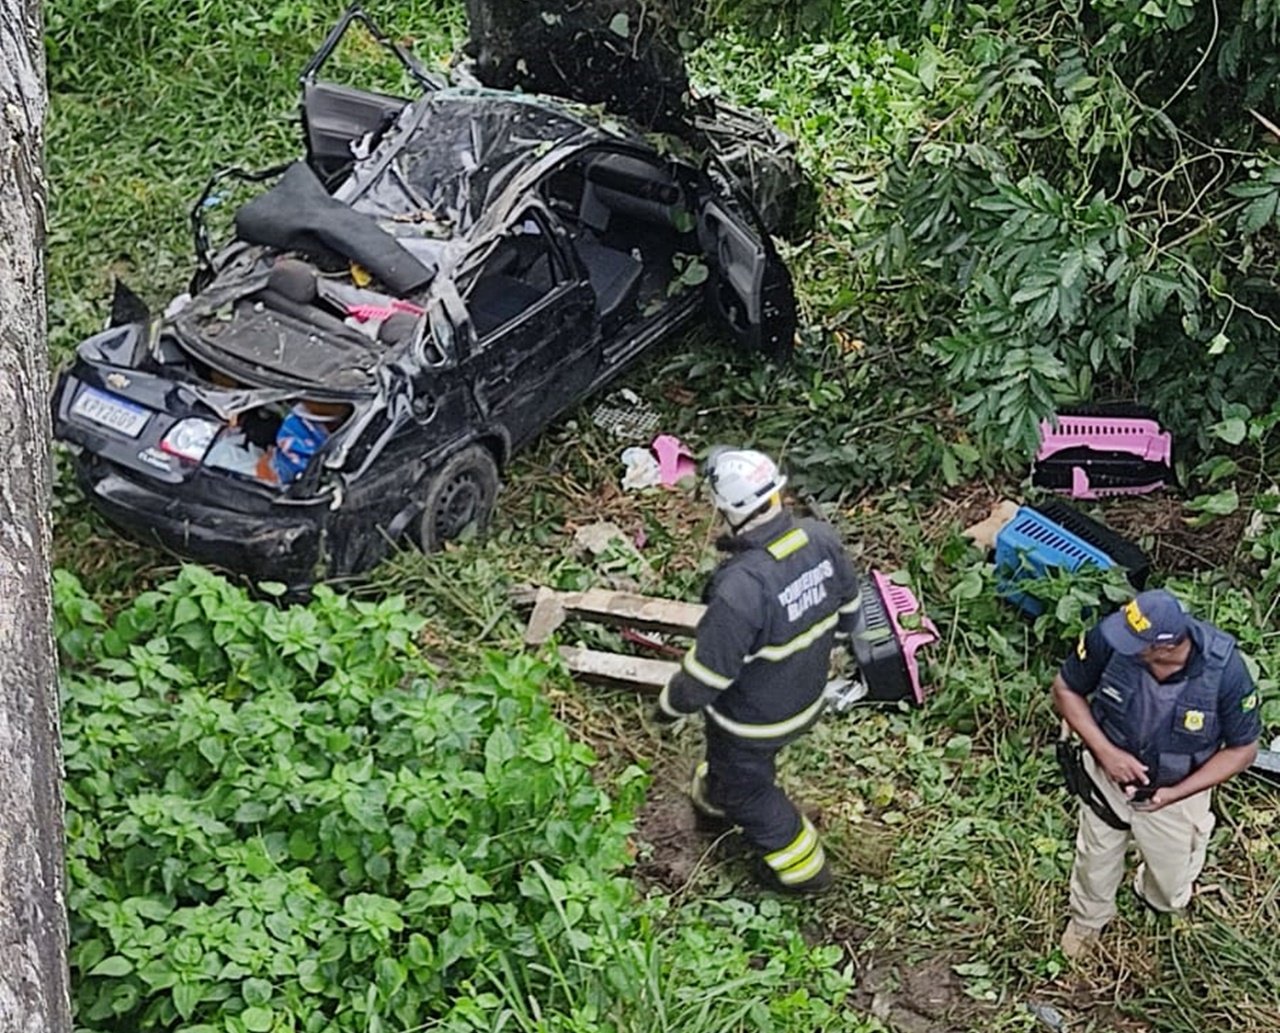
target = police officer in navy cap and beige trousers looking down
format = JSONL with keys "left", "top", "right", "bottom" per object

{"left": 1053, "top": 590, "right": 1262, "bottom": 959}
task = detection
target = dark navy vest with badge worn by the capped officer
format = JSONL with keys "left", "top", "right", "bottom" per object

{"left": 1089, "top": 621, "right": 1235, "bottom": 787}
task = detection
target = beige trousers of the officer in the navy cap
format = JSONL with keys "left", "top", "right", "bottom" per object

{"left": 1070, "top": 750, "right": 1213, "bottom": 929}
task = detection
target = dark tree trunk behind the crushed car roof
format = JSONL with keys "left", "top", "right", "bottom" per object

{"left": 467, "top": 0, "right": 695, "bottom": 133}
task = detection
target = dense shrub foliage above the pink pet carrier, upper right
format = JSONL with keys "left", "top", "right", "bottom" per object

{"left": 699, "top": 0, "right": 1280, "bottom": 458}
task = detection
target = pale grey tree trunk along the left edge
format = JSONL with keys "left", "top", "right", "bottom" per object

{"left": 0, "top": 0, "right": 72, "bottom": 1033}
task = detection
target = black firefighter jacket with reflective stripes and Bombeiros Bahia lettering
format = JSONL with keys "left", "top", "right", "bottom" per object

{"left": 658, "top": 511, "right": 860, "bottom": 748}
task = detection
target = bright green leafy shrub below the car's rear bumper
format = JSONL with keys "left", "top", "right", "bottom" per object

{"left": 58, "top": 567, "right": 635, "bottom": 1033}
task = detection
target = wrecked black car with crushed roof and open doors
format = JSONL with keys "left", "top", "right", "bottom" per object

{"left": 54, "top": 6, "right": 795, "bottom": 589}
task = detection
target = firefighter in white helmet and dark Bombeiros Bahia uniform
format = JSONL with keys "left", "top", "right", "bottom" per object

{"left": 655, "top": 448, "right": 860, "bottom": 893}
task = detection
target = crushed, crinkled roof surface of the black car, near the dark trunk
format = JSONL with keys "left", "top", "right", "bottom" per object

{"left": 355, "top": 90, "right": 584, "bottom": 237}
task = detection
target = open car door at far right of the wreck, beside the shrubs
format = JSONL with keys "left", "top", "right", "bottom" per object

{"left": 698, "top": 181, "right": 796, "bottom": 361}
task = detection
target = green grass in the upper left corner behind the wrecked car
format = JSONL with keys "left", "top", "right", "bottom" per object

{"left": 45, "top": 0, "right": 463, "bottom": 357}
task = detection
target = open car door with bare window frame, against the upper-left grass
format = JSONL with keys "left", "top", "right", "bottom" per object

{"left": 298, "top": 4, "right": 444, "bottom": 192}
